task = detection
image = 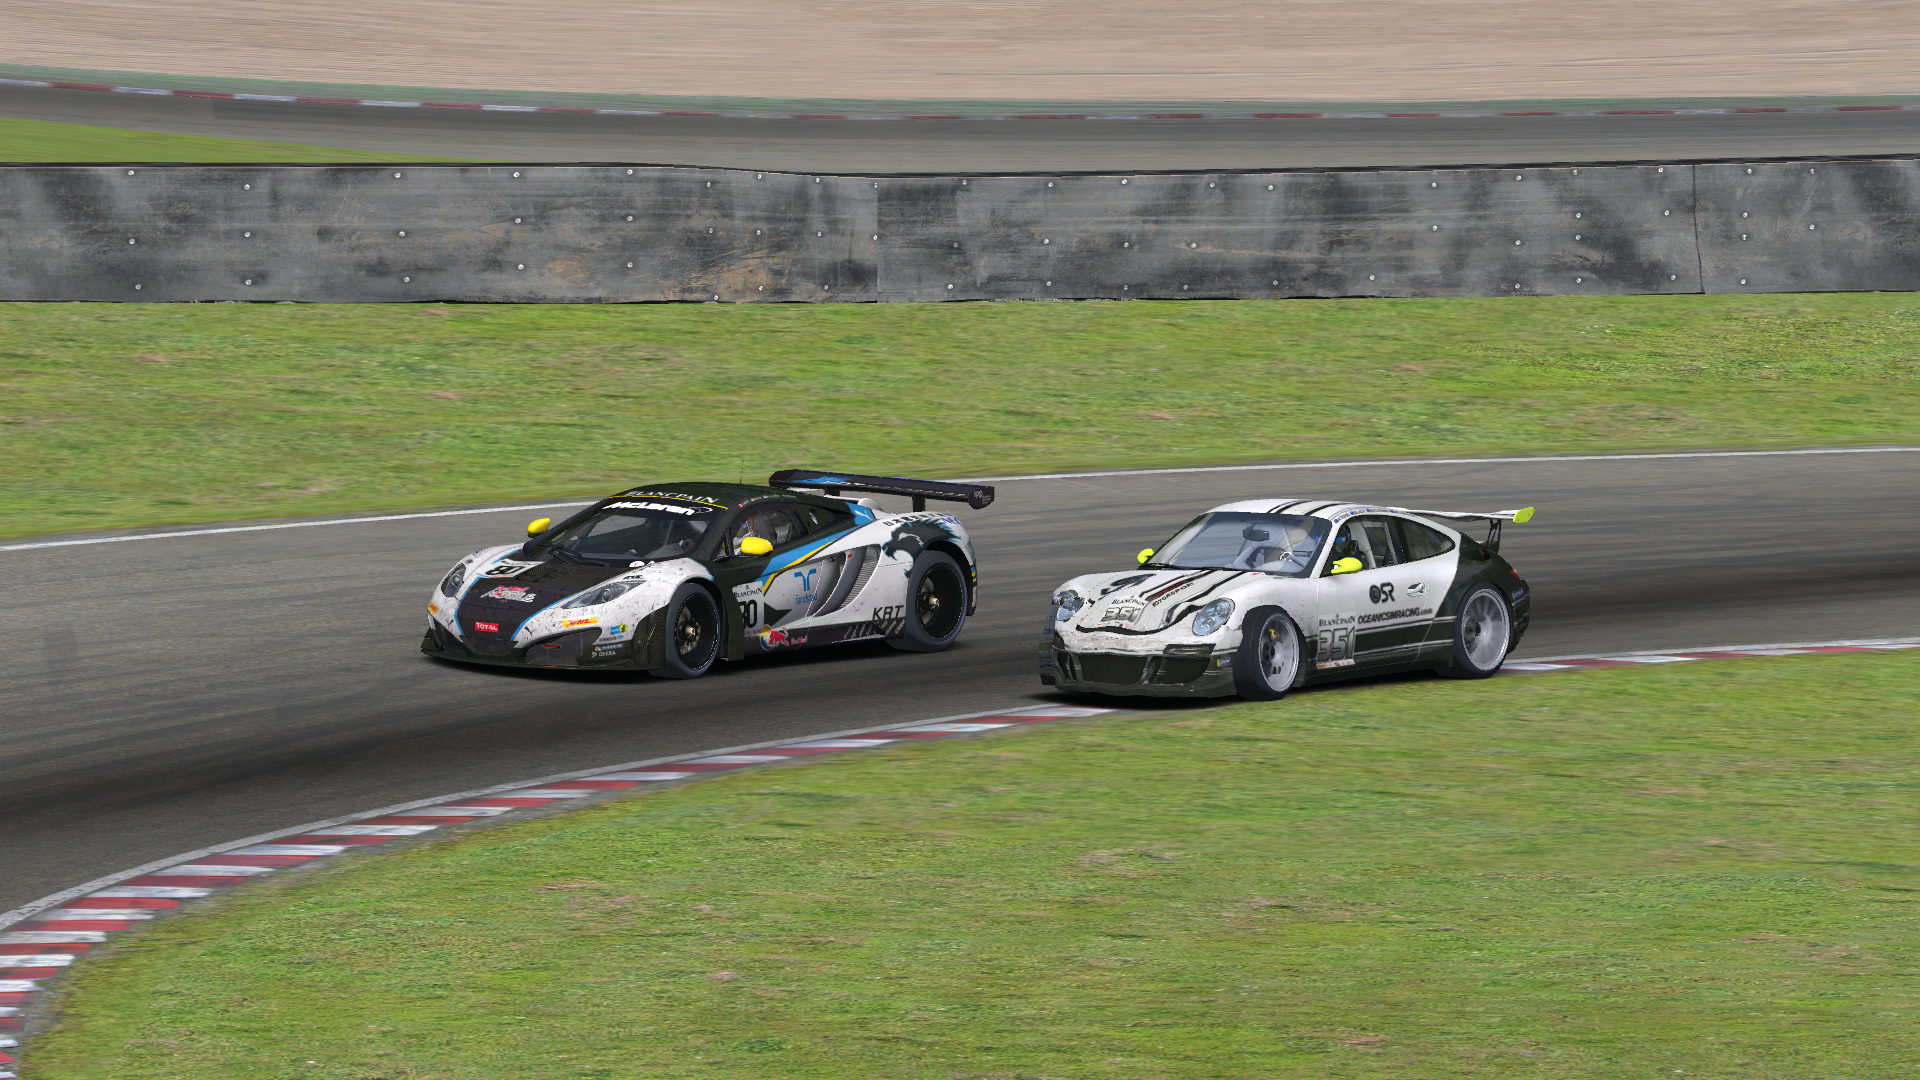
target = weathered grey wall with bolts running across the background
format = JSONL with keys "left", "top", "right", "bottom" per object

{"left": 0, "top": 160, "right": 1920, "bottom": 302}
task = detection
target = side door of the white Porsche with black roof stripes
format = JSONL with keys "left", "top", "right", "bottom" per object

{"left": 1313, "top": 515, "right": 1432, "bottom": 671}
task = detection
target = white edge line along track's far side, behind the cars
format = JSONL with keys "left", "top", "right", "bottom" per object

{"left": 0, "top": 446, "right": 1920, "bottom": 552}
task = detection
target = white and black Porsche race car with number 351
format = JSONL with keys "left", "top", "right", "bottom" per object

{"left": 1041, "top": 500, "right": 1534, "bottom": 700}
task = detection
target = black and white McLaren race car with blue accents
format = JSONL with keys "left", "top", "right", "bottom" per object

{"left": 420, "top": 469, "right": 993, "bottom": 678}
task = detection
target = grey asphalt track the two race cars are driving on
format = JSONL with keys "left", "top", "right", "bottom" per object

{"left": 0, "top": 454, "right": 1920, "bottom": 909}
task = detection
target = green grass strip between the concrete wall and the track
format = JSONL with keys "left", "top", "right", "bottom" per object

{"left": 0, "top": 294, "right": 1920, "bottom": 536}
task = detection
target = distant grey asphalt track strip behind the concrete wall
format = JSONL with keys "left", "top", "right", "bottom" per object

{"left": 11, "top": 86, "right": 1920, "bottom": 173}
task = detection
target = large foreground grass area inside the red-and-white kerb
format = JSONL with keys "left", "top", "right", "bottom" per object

{"left": 27, "top": 653, "right": 1920, "bottom": 1080}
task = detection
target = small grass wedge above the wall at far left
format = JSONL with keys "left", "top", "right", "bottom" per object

{"left": 0, "top": 117, "right": 472, "bottom": 165}
